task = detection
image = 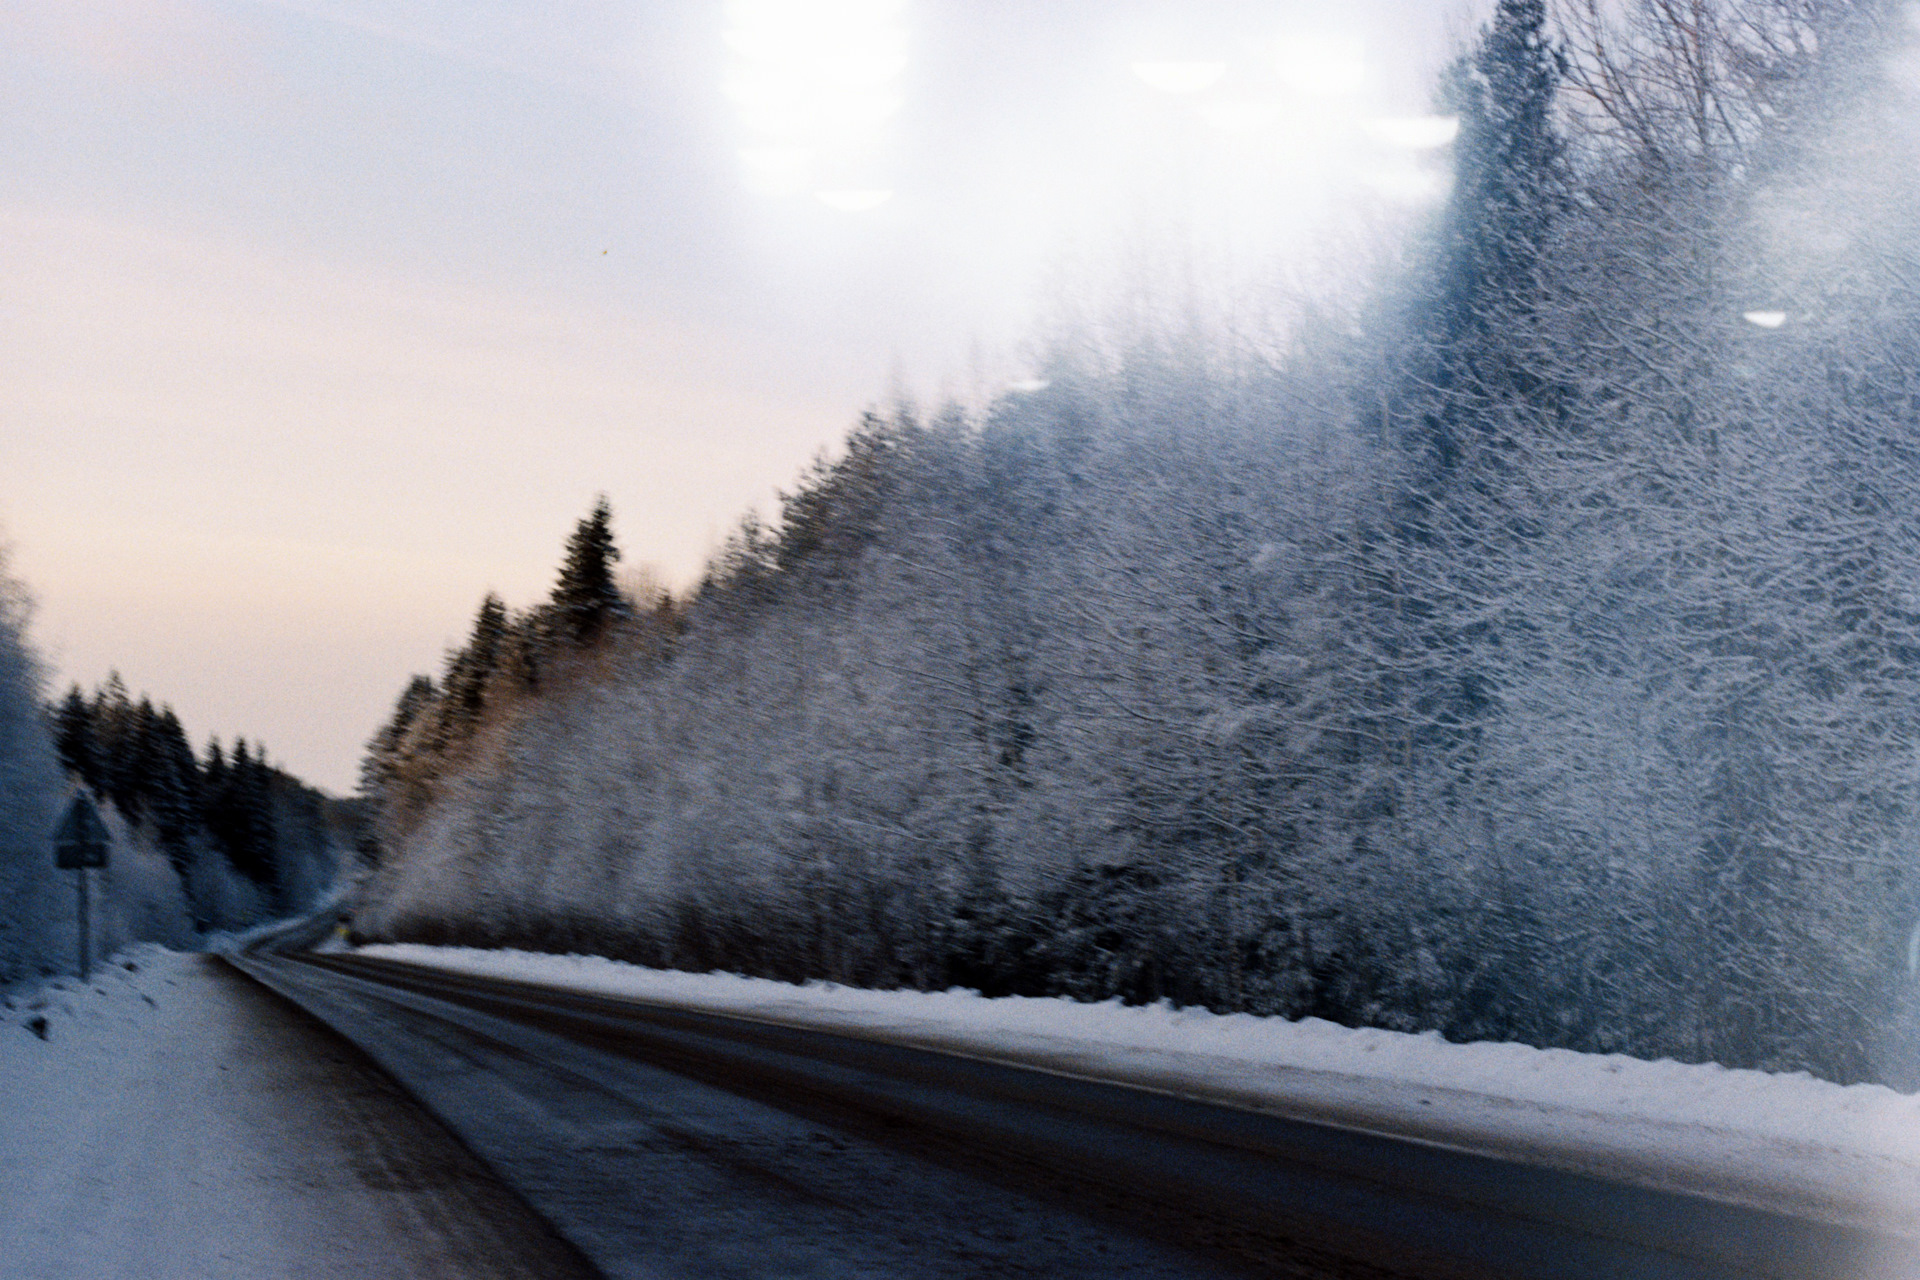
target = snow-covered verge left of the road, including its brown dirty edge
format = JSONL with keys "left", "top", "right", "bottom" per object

{"left": 0, "top": 946, "right": 586, "bottom": 1280}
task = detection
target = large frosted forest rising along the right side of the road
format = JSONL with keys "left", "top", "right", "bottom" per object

{"left": 355, "top": 0, "right": 1920, "bottom": 1088}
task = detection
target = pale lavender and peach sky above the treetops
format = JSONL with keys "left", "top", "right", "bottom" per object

{"left": 0, "top": 0, "right": 1484, "bottom": 793}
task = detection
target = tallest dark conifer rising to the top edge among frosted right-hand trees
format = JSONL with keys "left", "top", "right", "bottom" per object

{"left": 1350, "top": 0, "right": 1574, "bottom": 909}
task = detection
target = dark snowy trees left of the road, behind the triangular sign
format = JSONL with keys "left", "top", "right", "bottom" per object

{"left": 0, "top": 558, "right": 339, "bottom": 986}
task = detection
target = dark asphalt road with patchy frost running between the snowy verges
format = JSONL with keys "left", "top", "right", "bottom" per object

{"left": 234, "top": 956, "right": 1920, "bottom": 1280}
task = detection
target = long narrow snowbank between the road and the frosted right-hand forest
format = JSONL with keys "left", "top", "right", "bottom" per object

{"left": 359, "top": 944, "right": 1920, "bottom": 1236}
